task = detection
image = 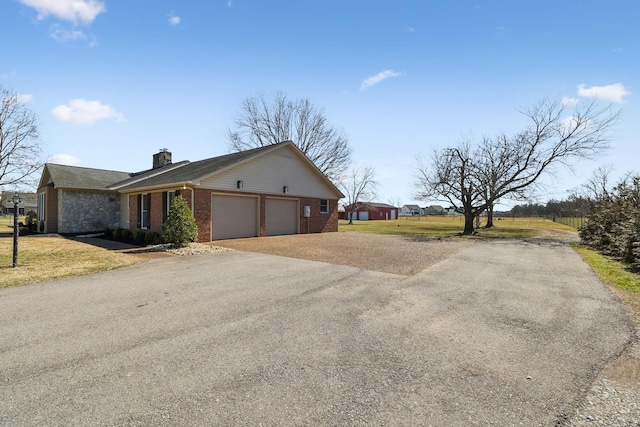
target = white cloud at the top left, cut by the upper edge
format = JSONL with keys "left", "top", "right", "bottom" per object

{"left": 19, "top": 0, "right": 107, "bottom": 24}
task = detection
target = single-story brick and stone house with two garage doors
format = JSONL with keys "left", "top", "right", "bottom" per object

{"left": 37, "top": 141, "right": 344, "bottom": 242}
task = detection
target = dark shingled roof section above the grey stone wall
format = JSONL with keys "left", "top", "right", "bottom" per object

{"left": 40, "top": 163, "right": 132, "bottom": 190}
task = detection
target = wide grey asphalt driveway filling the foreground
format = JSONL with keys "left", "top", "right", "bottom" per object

{"left": 0, "top": 242, "right": 632, "bottom": 426}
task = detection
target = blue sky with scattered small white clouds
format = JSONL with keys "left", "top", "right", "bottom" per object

{"left": 0, "top": 0, "right": 640, "bottom": 211}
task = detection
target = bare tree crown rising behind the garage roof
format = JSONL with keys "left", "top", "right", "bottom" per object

{"left": 228, "top": 92, "right": 351, "bottom": 180}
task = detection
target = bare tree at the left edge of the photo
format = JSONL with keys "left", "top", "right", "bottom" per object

{"left": 0, "top": 85, "right": 41, "bottom": 187}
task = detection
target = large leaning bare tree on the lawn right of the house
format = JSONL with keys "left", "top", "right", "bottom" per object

{"left": 416, "top": 100, "right": 619, "bottom": 234}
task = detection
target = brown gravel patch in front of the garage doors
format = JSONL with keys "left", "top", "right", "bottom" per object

{"left": 212, "top": 232, "right": 473, "bottom": 276}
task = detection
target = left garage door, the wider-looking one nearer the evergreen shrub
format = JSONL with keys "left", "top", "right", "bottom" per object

{"left": 211, "top": 195, "right": 258, "bottom": 240}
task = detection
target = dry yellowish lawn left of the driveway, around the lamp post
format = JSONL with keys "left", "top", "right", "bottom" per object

{"left": 0, "top": 235, "right": 146, "bottom": 288}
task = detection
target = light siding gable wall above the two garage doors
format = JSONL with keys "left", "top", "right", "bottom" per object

{"left": 200, "top": 145, "right": 337, "bottom": 199}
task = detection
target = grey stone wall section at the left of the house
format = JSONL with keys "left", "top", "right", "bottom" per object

{"left": 57, "top": 190, "right": 120, "bottom": 233}
